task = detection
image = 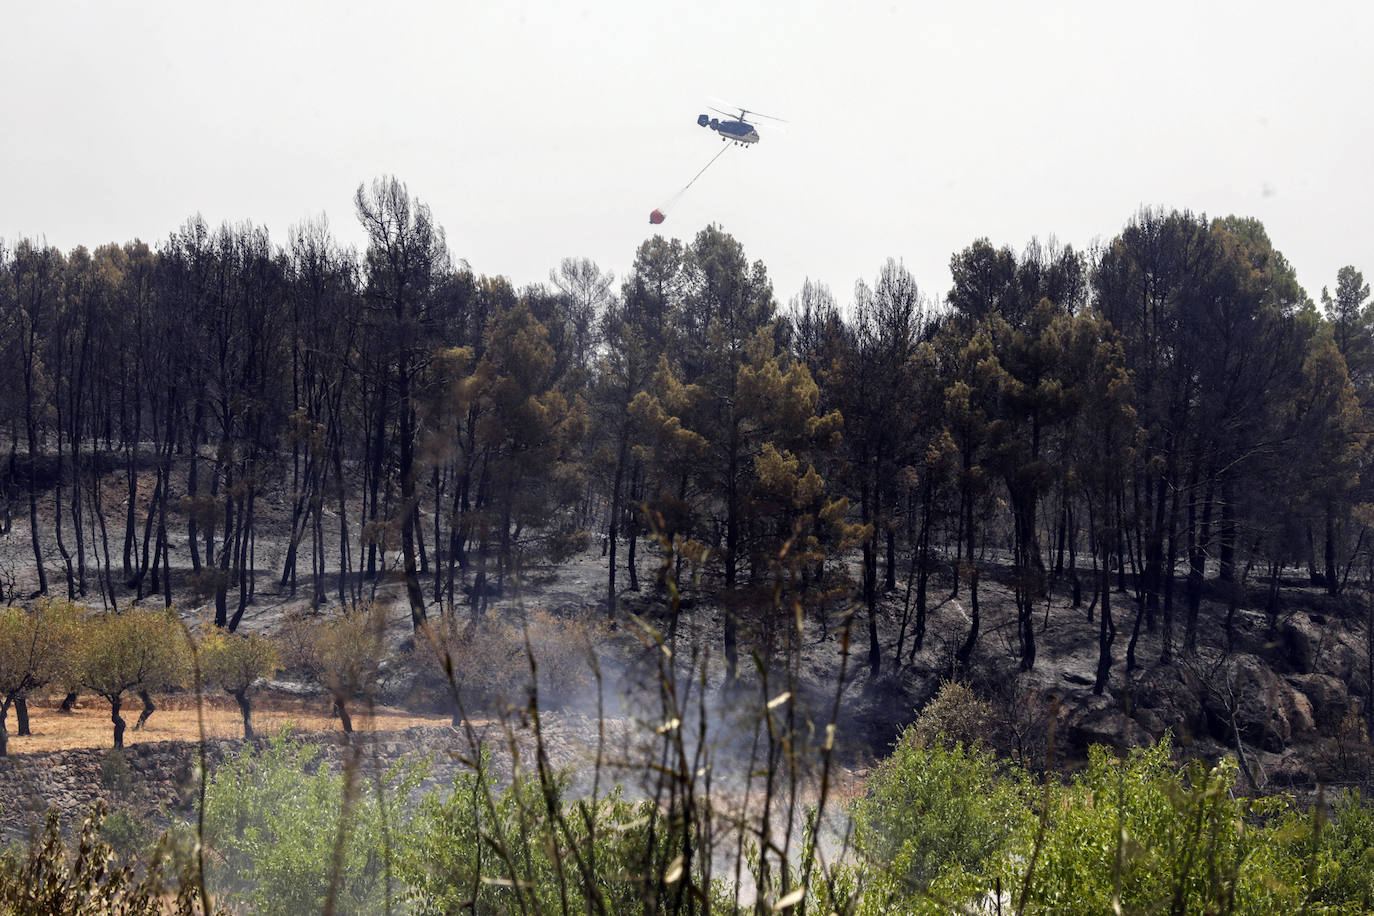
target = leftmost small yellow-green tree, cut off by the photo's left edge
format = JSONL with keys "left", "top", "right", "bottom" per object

{"left": 0, "top": 602, "right": 80, "bottom": 757}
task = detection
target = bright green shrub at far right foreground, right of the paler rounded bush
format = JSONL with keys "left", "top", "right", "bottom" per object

{"left": 1025, "top": 742, "right": 1352, "bottom": 916}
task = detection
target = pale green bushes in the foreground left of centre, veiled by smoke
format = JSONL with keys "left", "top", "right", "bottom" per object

{"left": 205, "top": 737, "right": 682, "bottom": 916}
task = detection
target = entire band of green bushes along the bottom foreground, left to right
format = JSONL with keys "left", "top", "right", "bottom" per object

{"left": 13, "top": 733, "right": 1374, "bottom": 916}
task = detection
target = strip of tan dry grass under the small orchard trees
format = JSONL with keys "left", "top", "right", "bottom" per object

{"left": 7, "top": 695, "right": 449, "bottom": 754}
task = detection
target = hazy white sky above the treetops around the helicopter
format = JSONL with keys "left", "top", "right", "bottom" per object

{"left": 0, "top": 0, "right": 1374, "bottom": 305}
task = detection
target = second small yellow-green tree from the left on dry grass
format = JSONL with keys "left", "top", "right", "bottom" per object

{"left": 78, "top": 610, "right": 190, "bottom": 747}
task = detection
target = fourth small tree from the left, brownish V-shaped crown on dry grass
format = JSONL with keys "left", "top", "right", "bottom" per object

{"left": 286, "top": 603, "right": 386, "bottom": 733}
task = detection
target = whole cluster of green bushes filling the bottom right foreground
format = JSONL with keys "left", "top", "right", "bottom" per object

{"left": 849, "top": 740, "right": 1374, "bottom": 916}
